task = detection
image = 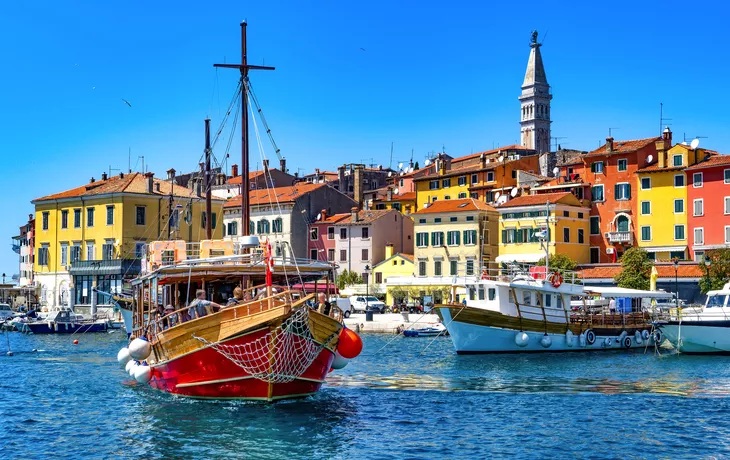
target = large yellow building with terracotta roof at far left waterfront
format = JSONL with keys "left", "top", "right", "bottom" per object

{"left": 32, "top": 173, "right": 224, "bottom": 306}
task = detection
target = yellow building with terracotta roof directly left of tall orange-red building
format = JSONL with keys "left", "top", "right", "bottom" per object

{"left": 497, "top": 192, "right": 590, "bottom": 264}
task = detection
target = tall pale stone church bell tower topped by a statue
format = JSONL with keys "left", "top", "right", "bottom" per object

{"left": 519, "top": 30, "right": 553, "bottom": 153}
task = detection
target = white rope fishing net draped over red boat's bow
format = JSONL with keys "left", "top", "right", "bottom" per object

{"left": 191, "top": 307, "right": 334, "bottom": 383}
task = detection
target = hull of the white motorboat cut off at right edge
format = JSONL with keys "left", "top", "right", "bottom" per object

{"left": 659, "top": 321, "right": 730, "bottom": 354}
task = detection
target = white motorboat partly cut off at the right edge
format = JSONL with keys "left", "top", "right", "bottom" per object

{"left": 657, "top": 283, "right": 730, "bottom": 354}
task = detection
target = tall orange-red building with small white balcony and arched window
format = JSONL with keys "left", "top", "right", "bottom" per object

{"left": 582, "top": 137, "right": 660, "bottom": 263}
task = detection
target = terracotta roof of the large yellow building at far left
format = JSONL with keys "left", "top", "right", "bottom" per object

{"left": 33, "top": 173, "right": 205, "bottom": 202}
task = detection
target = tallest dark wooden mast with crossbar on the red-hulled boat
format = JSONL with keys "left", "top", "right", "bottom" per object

{"left": 213, "top": 21, "right": 274, "bottom": 236}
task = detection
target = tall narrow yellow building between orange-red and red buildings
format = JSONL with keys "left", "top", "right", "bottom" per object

{"left": 636, "top": 135, "right": 714, "bottom": 260}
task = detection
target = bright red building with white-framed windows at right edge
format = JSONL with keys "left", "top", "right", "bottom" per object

{"left": 685, "top": 155, "right": 730, "bottom": 260}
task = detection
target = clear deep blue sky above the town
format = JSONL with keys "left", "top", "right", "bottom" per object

{"left": 0, "top": 0, "right": 730, "bottom": 274}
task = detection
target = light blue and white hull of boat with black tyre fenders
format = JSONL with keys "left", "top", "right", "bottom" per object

{"left": 439, "top": 308, "right": 654, "bottom": 354}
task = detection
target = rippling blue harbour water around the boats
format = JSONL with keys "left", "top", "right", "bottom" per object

{"left": 0, "top": 331, "right": 730, "bottom": 459}
